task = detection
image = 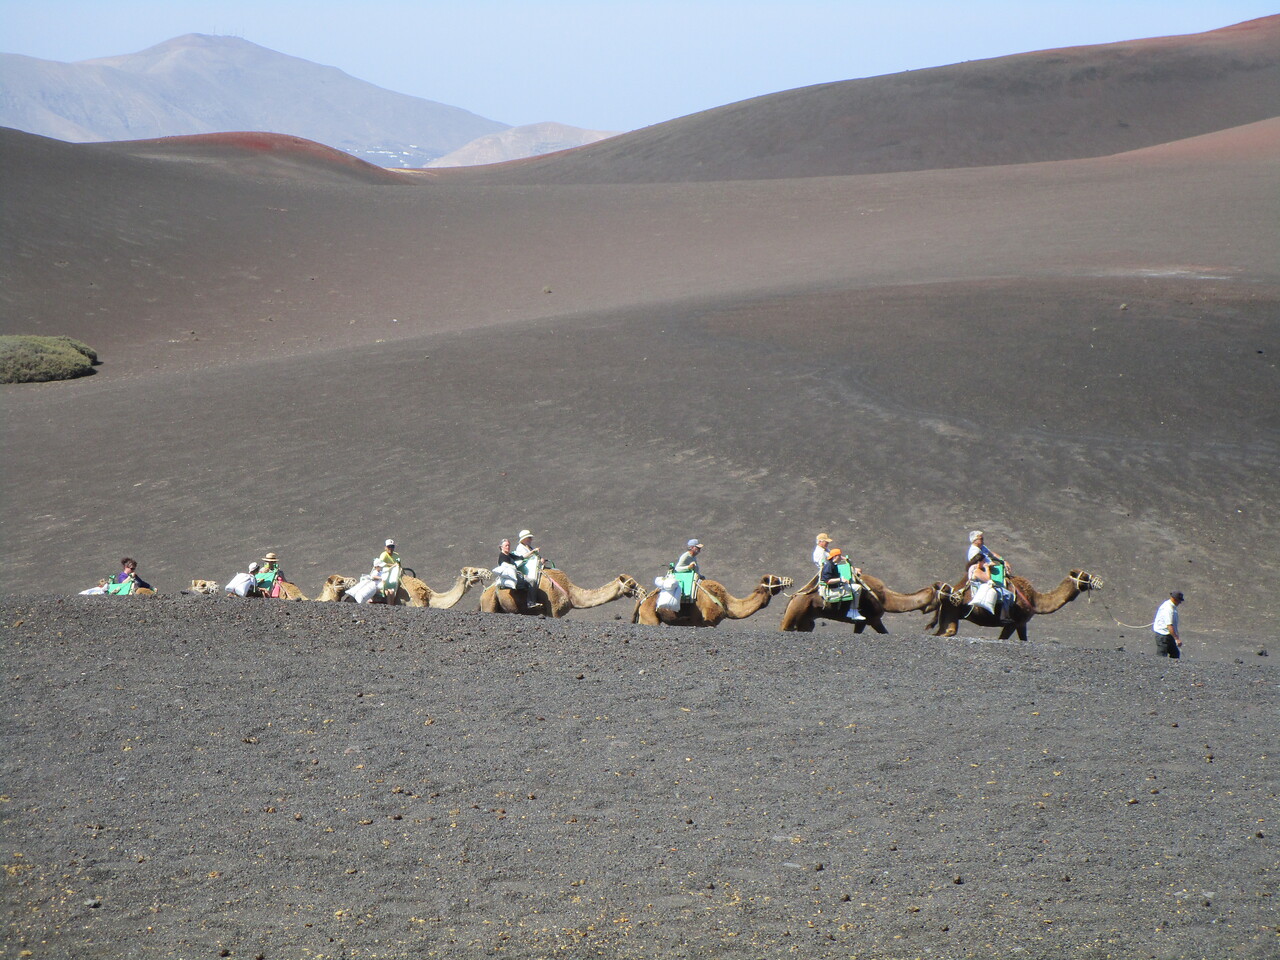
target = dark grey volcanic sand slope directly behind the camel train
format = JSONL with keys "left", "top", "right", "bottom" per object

{"left": 6, "top": 273, "right": 1280, "bottom": 659}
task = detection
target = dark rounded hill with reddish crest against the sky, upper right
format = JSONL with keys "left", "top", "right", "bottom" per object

{"left": 448, "top": 17, "right": 1280, "bottom": 183}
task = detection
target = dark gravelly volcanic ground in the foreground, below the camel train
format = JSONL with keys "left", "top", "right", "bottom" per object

{"left": 0, "top": 598, "right": 1280, "bottom": 959}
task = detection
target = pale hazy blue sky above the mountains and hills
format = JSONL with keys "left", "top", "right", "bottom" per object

{"left": 0, "top": 0, "right": 1280, "bottom": 131}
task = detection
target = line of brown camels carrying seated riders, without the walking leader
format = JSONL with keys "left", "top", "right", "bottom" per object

{"left": 82, "top": 530, "right": 1102, "bottom": 640}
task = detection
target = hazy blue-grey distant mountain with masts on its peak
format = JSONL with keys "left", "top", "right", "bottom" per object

{"left": 0, "top": 33, "right": 507, "bottom": 166}
